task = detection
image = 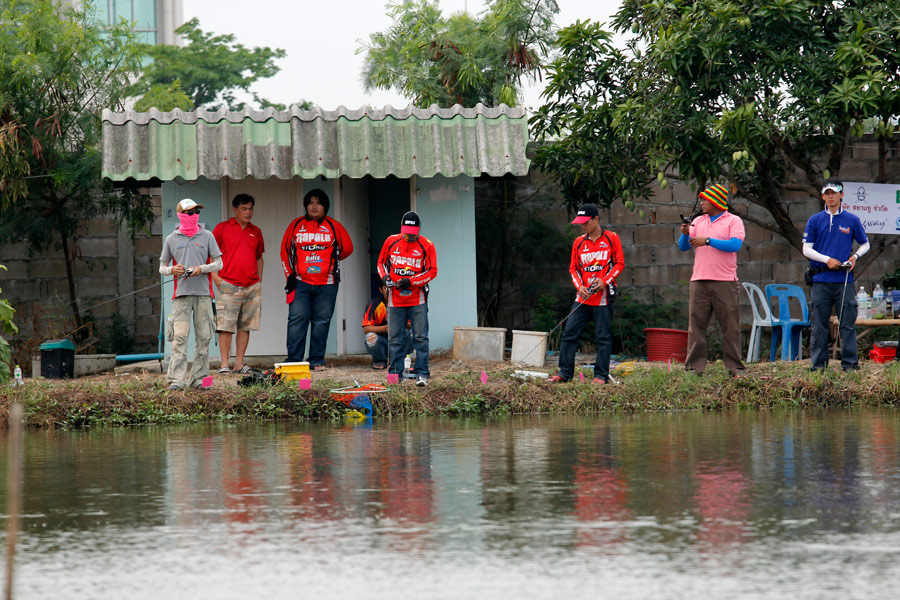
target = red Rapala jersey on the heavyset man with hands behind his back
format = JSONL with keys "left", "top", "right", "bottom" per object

{"left": 281, "top": 215, "right": 353, "bottom": 285}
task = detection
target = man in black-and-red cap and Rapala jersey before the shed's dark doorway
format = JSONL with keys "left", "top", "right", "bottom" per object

{"left": 378, "top": 211, "right": 437, "bottom": 387}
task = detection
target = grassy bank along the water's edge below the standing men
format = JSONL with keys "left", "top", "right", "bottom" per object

{"left": 0, "top": 362, "right": 900, "bottom": 428}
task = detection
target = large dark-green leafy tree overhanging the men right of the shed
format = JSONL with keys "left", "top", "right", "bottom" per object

{"left": 532, "top": 0, "right": 900, "bottom": 267}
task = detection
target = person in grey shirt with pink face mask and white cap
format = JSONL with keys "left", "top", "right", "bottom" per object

{"left": 159, "top": 198, "right": 222, "bottom": 391}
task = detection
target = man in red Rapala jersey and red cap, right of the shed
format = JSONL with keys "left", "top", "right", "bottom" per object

{"left": 550, "top": 204, "right": 625, "bottom": 383}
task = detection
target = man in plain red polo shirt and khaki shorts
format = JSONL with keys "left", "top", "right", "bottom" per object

{"left": 213, "top": 194, "right": 266, "bottom": 373}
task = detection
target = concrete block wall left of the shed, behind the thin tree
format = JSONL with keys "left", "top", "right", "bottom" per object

{"left": 0, "top": 189, "right": 162, "bottom": 352}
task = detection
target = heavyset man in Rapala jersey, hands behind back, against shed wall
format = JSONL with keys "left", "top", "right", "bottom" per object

{"left": 281, "top": 189, "right": 353, "bottom": 371}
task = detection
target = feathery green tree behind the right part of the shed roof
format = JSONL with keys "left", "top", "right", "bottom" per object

{"left": 357, "top": 0, "right": 559, "bottom": 107}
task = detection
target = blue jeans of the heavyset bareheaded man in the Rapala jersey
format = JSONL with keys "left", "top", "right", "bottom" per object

{"left": 286, "top": 281, "right": 338, "bottom": 367}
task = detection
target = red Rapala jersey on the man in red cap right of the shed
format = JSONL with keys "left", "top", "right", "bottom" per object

{"left": 569, "top": 229, "right": 625, "bottom": 306}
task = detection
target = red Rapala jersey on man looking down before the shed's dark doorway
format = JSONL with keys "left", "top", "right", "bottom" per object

{"left": 378, "top": 233, "right": 437, "bottom": 306}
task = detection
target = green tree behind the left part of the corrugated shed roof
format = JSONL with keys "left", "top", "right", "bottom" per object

{"left": 131, "top": 19, "right": 285, "bottom": 110}
